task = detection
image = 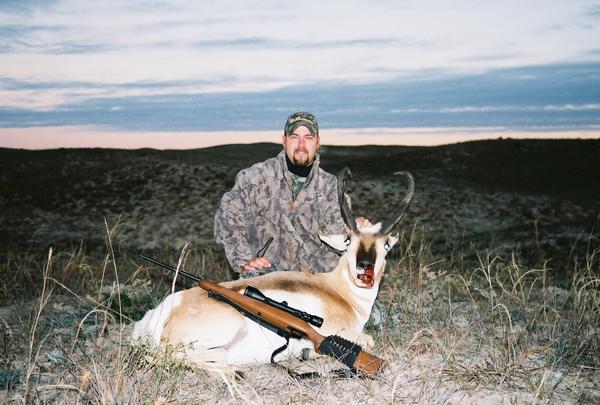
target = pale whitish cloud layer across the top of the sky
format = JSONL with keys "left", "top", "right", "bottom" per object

{"left": 0, "top": 0, "right": 600, "bottom": 117}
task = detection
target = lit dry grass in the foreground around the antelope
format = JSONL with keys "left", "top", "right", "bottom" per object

{"left": 0, "top": 219, "right": 600, "bottom": 403}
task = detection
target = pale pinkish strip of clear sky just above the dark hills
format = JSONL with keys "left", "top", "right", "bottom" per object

{"left": 0, "top": 128, "right": 600, "bottom": 150}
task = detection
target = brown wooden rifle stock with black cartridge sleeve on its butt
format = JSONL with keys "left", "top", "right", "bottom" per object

{"left": 198, "top": 279, "right": 384, "bottom": 377}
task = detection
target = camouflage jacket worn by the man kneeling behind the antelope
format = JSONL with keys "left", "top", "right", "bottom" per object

{"left": 214, "top": 150, "right": 345, "bottom": 272}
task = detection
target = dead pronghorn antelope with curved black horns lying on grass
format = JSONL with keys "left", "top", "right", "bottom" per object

{"left": 133, "top": 168, "right": 414, "bottom": 369}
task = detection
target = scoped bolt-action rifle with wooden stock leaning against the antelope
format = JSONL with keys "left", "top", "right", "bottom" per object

{"left": 140, "top": 255, "right": 384, "bottom": 377}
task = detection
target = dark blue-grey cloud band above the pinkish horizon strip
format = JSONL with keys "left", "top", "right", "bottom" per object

{"left": 0, "top": 63, "right": 600, "bottom": 132}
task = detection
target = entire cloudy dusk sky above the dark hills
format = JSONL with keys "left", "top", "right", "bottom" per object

{"left": 0, "top": 0, "right": 600, "bottom": 148}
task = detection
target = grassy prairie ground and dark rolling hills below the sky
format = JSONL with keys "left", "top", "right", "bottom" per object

{"left": 0, "top": 140, "right": 600, "bottom": 403}
